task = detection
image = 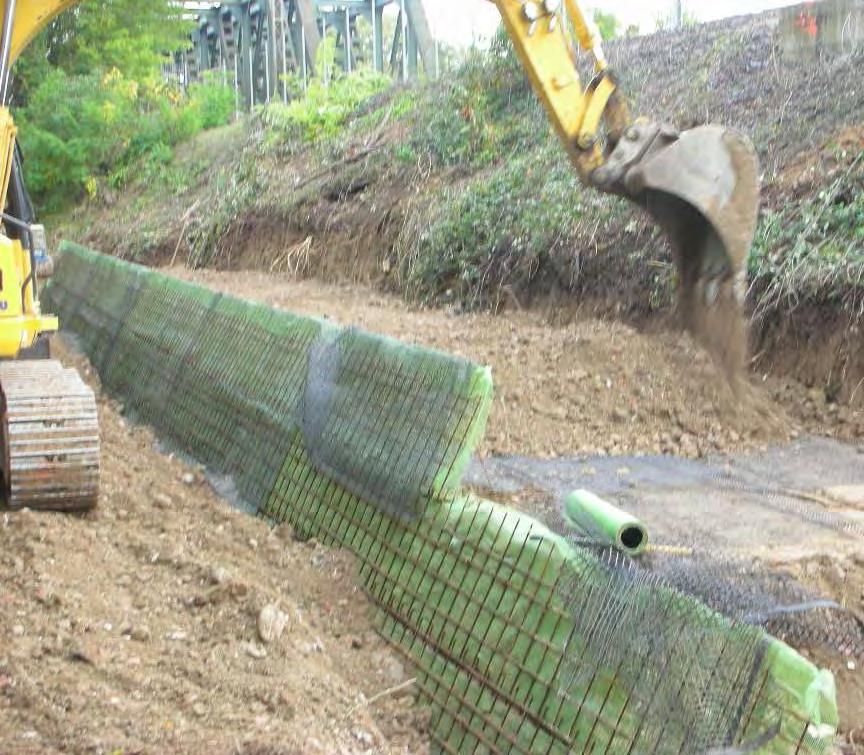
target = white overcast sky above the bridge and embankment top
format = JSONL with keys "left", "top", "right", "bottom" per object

{"left": 424, "top": 0, "right": 794, "bottom": 45}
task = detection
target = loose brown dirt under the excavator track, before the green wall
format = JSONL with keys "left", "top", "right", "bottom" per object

{"left": 0, "top": 344, "right": 426, "bottom": 755}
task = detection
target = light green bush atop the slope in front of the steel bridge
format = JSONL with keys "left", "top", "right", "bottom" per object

{"left": 260, "top": 70, "right": 390, "bottom": 146}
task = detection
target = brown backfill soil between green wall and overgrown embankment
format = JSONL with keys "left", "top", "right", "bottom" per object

{"left": 170, "top": 267, "right": 864, "bottom": 458}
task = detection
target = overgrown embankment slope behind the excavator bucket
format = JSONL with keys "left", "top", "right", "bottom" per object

{"left": 54, "top": 14, "right": 864, "bottom": 396}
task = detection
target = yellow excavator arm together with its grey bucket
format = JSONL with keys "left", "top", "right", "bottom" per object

{"left": 493, "top": 0, "right": 759, "bottom": 374}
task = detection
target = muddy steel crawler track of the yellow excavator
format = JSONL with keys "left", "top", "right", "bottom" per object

{"left": 0, "top": 360, "right": 100, "bottom": 511}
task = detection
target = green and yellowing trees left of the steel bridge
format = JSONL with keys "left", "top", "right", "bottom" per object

{"left": 13, "top": 0, "right": 234, "bottom": 208}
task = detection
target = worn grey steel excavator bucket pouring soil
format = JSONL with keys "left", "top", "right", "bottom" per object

{"left": 626, "top": 125, "right": 759, "bottom": 371}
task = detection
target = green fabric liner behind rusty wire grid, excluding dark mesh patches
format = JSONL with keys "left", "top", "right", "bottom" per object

{"left": 45, "top": 242, "right": 837, "bottom": 755}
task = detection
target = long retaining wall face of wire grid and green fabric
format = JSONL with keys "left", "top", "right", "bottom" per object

{"left": 44, "top": 244, "right": 837, "bottom": 755}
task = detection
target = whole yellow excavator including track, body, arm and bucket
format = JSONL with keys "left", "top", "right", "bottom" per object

{"left": 0, "top": 0, "right": 759, "bottom": 511}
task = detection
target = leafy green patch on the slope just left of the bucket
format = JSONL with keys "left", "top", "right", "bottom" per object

{"left": 400, "top": 147, "right": 610, "bottom": 307}
